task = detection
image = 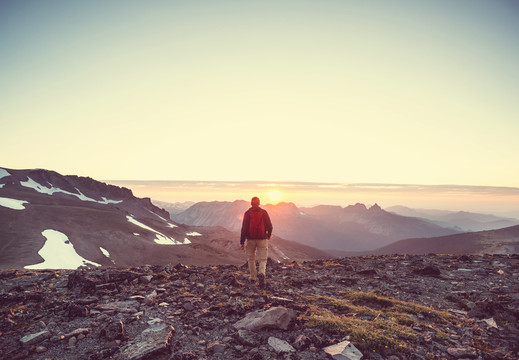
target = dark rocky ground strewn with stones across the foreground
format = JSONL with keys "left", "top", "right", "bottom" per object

{"left": 0, "top": 255, "right": 519, "bottom": 360}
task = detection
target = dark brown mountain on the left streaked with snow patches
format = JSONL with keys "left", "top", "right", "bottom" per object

{"left": 0, "top": 168, "right": 327, "bottom": 268}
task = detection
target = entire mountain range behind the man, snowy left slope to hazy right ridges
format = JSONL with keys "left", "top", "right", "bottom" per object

{"left": 0, "top": 168, "right": 519, "bottom": 269}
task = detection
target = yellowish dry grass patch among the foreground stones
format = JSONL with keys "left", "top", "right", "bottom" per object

{"left": 301, "top": 291, "right": 456, "bottom": 354}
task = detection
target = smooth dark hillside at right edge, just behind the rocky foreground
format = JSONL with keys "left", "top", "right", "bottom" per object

{"left": 370, "top": 225, "right": 519, "bottom": 255}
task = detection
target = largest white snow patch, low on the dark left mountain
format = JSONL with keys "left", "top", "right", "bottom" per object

{"left": 25, "top": 229, "right": 101, "bottom": 269}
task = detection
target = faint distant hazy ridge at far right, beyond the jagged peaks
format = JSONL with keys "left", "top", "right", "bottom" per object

{"left": 386, "top": 206, "right": 519, "bottom": 231}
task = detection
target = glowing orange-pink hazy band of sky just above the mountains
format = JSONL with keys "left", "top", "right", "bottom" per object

{"left": 104, "top": 180, "right": 519, "bottom": 219}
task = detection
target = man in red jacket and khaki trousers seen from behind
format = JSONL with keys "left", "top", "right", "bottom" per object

{"left": 240, "top": 197, "right": 272, "bottom": 289}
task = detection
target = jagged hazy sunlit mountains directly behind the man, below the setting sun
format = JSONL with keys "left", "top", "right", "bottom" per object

{"left": 171, "top": 201, "right": 456, "bottom": 251}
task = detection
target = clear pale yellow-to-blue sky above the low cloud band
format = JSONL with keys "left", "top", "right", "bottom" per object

{"left": 0, "top": 0, "right": 519, "bottom": 202}
